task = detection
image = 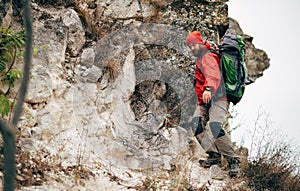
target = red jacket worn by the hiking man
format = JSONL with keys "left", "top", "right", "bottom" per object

{"left": 194, "top": 52, "right": 221, "bottom": 104}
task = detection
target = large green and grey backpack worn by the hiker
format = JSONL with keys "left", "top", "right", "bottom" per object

{"left": 213, "top": 34, "right": 248, "bottom": 105}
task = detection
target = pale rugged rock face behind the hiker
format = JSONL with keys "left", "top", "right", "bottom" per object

{"left": 0, "top": 0, "right": 269, "bottom": 190}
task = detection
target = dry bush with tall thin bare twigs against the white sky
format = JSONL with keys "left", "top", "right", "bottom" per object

{"left": 243, "top": 109, "right": 300, "bottom": 191}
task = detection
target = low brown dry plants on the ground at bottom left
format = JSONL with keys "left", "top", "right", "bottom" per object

{"left": 0, "top": 147, "right": 94, "bottom": 188}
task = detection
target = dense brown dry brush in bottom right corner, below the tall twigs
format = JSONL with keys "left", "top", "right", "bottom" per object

{"left": 244, "top": 139, "right": 300, "bottom": 191}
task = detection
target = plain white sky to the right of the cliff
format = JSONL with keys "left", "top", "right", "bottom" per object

{"left": 228, "top": 0, "right": 300, "bottom": 148}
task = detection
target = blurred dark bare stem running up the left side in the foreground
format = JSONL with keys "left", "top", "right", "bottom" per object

{"left": 0, "top": 0, "right": 32, "bottom": 191}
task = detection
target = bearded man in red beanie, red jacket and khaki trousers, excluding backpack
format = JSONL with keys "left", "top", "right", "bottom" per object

{"left": 186, "top": 31, "right": 239, "bottom": 176}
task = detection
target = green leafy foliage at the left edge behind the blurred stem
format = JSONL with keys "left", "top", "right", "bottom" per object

{"left": 0, "top": 27, "right": 26, "bottom": 117}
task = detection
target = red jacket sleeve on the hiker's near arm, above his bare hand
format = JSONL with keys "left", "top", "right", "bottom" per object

{"left": 202, "top": 53, "right": 221, "bottom": 93}
